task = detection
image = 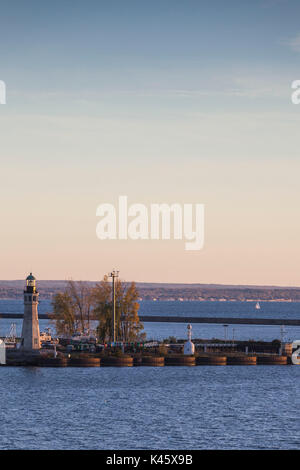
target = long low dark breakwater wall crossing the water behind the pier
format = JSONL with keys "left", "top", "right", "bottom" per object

{"left": 0, "top": 313, "right": 300, "bottom": 326}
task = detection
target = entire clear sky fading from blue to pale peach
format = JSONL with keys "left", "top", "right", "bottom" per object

{"left": 0, "top": 0, "right": 300, "bottom": 286}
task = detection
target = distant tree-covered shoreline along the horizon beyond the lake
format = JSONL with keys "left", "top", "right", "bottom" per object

{"left": 0, "top": 281, "right": 300, "bottom": 302}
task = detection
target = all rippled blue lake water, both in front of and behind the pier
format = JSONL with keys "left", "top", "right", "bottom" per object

{"left": 0, "top": 300, "right": 300, "bottom": 450}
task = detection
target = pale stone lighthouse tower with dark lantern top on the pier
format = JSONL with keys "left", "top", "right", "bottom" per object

{"left": 20, "top": 273, "right": 41, "bottom": 352}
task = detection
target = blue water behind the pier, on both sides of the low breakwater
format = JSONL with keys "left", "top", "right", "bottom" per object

{"left": 0, "top": 300, "right": 300, "bottom": 341}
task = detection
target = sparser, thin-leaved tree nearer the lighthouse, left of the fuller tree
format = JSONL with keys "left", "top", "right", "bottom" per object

{"left": 52, "top": 280, "right": 92, "bottom": 336}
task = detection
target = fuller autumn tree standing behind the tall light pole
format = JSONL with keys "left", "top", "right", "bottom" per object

{"left": 93, "top": 276, "right": 146, "bottom": 342}
